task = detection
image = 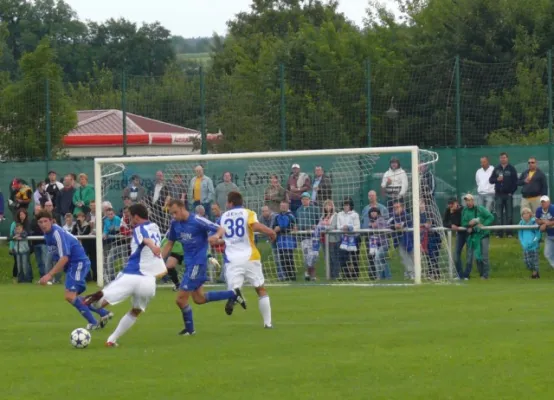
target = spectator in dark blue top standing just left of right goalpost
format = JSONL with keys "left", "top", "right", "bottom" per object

{"left": 389, "top": 200, "right": 415, "bottom": 279}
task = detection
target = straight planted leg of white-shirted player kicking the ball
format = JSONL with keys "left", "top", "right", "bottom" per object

{"left": 106, "top": 275, "right": 156, "bottom": 347}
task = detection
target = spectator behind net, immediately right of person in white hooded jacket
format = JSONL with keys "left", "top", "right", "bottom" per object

{"left": 362, "top": 207, "right": 392, "bottom": 280}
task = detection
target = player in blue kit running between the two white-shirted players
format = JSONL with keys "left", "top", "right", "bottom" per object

{"left": 162, "top": 200, "right": 246, "bottom": 336}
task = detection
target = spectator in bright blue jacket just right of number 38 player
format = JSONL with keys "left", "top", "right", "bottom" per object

{"left": 271, "top": 201, "right": 296, "bottom": 281}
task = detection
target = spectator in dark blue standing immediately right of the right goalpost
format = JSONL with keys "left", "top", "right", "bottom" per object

{"left": 420, "top": 205, "right": 442, "bottom": 280}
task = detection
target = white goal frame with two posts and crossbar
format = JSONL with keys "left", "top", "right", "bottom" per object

{"left": 94, "top": 146, "right": 421, "bottom": 287}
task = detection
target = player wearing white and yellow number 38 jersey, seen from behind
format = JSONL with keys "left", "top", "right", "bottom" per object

{"left": 221, "top": 192, "right": 277, "bottom": 329}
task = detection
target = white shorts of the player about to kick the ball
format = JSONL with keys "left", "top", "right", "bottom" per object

{"left": 101, "top": 274, "right": 156, "bottom": 311}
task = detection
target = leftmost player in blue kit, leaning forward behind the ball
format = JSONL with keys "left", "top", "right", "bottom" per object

{"left": 36, "top": 211, "right": 113, "bottom": 330}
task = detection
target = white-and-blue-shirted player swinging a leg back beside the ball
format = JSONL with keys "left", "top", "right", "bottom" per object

{"left": 81, "top": 204, "right": 167, "bottom": 347}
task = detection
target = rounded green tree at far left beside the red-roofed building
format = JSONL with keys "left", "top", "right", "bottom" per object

{"left": 0, "top": 39, "right": 77, "bottom": 160}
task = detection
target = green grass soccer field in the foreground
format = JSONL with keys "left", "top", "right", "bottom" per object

{"left": 0, "top": 279, "right": 554, "bottom": 400}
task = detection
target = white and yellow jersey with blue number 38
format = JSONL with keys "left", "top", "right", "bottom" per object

{"left": 220, "top": 207, "right": 261, "bottom": 264}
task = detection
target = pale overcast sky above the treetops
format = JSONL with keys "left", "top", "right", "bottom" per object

{"left": 65, "top": 0, "right": 394, "bottom": 37}
